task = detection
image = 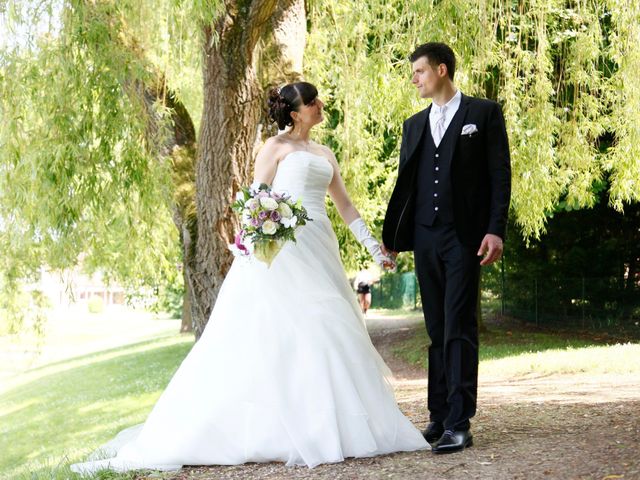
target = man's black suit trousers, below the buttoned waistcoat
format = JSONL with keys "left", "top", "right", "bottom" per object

{"left": 414, "top": 220, "right": 480, "bottom": 430}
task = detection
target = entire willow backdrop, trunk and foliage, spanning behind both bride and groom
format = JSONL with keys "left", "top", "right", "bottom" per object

{"left": 0, "top": 0, "right": 640, "bottom": 335}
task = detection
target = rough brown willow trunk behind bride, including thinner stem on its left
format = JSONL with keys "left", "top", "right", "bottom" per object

{"left": 140, "top": 0, "right": 306, "bottom": 340}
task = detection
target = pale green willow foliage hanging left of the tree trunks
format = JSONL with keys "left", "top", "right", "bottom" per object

{"left": 0, "top": 2, "right": 185, "bottom": 329}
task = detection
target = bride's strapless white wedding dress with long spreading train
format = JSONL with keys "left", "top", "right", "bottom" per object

{"left": 71, "top": 151, "right": 429, "bottom": 473}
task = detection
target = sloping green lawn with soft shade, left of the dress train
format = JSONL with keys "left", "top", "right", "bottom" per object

{"left": 0, "top": 337, "right": 193, "bottom": 478}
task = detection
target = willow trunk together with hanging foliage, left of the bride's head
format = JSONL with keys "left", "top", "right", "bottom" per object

{"left": 0, "top": 0, "right": 305, "bottom": 336}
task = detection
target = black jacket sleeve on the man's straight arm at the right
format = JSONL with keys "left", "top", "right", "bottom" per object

{"left": 487, "top": 103, "right": 511, "bottom": 239}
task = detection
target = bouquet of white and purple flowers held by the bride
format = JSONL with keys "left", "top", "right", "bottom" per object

{"left": 229, "top": 183, "right": 311, "bottom": 265}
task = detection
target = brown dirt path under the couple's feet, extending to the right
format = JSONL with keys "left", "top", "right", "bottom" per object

{"left": 159, "top": 317, "right": 640, "bottom": 480}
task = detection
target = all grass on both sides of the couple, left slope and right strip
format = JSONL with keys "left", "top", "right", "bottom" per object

{"left": 0, "top": 310, "right": 640, "bottom": 480}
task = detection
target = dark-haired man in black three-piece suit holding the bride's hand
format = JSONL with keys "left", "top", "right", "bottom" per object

{"left": 382, "top": 42, "right": 511, "bottom": 453}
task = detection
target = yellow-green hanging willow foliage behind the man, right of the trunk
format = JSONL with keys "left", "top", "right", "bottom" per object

{"left": 305, "top": 0, "right": 640, "bottom": 267}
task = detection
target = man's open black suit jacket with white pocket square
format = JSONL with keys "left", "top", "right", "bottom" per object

{"left": 382, "top": 95, "right": 511, "bottom": 252}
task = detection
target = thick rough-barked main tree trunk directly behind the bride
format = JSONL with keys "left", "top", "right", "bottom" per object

{"left": 187, "top": 0, "right": 284, "bottom": 339}
